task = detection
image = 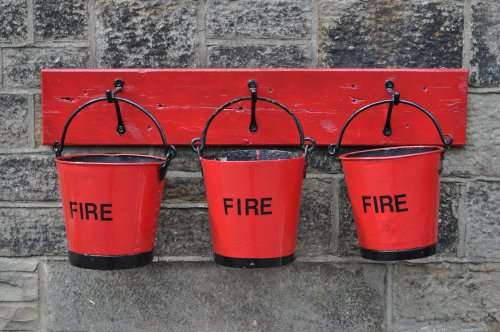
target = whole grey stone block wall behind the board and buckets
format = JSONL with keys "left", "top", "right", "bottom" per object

{"left": 0, "top": 0, "right": 500, "bottom": 331}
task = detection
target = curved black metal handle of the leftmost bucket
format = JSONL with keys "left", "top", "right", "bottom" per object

{"left": 52, "top": 96, "right": 177, "bottom": 181}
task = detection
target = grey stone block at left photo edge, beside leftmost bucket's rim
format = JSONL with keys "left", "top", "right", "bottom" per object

{"left": 0, "top": 154, "right": 60, "bottom": 201}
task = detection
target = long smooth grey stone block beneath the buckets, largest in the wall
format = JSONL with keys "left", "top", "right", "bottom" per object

{"left": 47, "top": 262, "right": 385, "bottom": 331}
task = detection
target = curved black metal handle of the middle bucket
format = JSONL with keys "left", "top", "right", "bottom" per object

{"left": 191, "top": 96, "right": 316, "bottom": 157}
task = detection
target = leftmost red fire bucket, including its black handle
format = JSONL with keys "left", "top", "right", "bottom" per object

{"left": 53, "top": 97, "right": 175, "bottom": 270}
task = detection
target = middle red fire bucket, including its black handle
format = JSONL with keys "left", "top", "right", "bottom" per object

{"left": 192, "top": 91, "right": 315, "bottom": 268}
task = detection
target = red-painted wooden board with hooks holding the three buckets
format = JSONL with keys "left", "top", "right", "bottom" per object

{"left": 42, "top": 69, "right": 468, "bottom": 146}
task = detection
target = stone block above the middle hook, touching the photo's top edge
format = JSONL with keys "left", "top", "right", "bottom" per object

{"left": 206, "top": 0, "right": 312, "bottom": 39}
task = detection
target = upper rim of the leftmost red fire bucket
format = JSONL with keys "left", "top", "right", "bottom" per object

{"left": 56, "top": 153, "right": 165, "bottom": 166}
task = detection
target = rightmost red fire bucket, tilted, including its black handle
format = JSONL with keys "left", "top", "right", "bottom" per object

{"left": 329, "top": 100, "right": 453, "bottom": 261}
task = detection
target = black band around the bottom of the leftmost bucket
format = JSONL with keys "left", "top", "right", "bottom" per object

{"left": 68, "top": 251, "right": 153, "bottom": 270}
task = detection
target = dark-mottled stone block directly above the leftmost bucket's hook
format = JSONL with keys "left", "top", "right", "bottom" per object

{"left": 95, "top": 0, "right": 198, "bottom": 67}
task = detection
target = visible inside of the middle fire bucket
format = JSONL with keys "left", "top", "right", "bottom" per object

{"left": 203, "top": 150, "right": 302, "bottom": 161}
